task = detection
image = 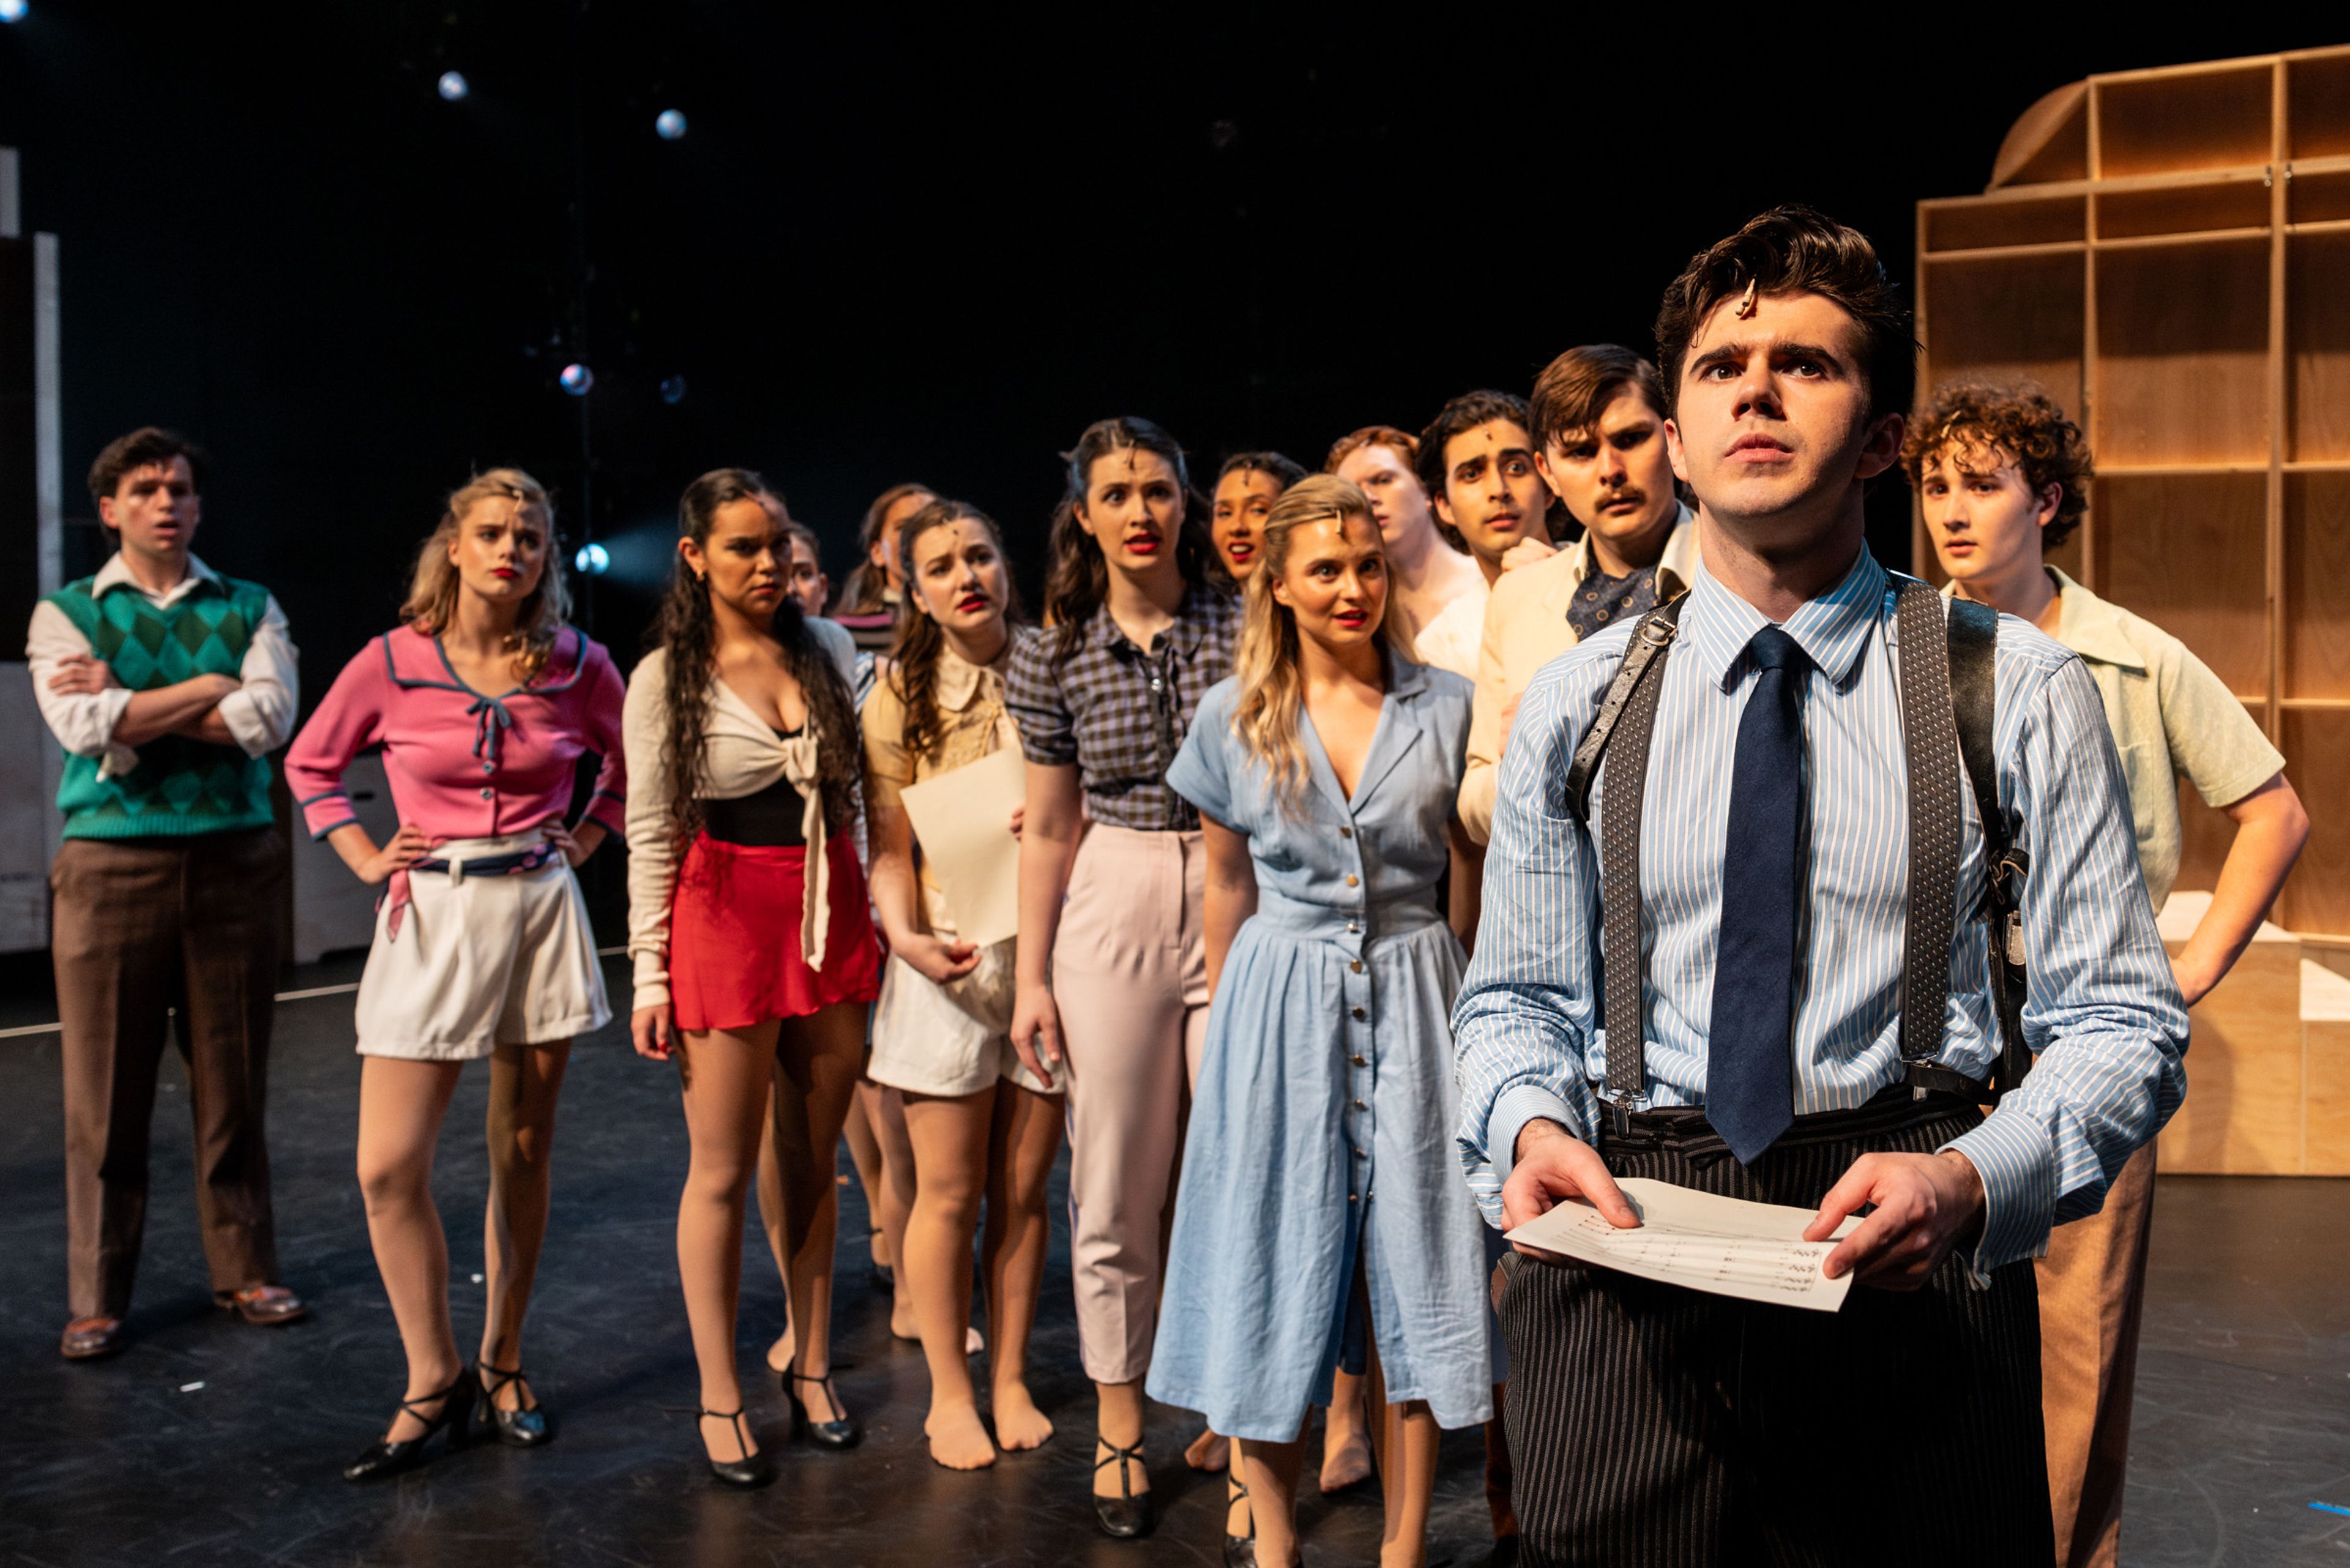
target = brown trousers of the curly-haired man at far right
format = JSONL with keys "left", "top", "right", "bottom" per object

{"left": 2040, "top": 1145, "right": 2155, "bottom": 1568}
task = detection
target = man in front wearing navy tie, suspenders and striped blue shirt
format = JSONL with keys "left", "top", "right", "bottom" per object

{"left": 1452, "top": 207, "right": 2188, "bottom": 1568}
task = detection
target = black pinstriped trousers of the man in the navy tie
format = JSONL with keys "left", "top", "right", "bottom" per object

{"left": 1502, "top": 1102, "right": 2054, "bottom": 1568}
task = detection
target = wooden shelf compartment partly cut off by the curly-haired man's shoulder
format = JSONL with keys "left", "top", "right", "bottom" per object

{"left": 2089, "top": 472, "right": 2268, "bottom": 703}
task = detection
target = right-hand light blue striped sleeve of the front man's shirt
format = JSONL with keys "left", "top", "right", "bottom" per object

{"left": 1944, "top": 637, "right": 2188, "bottom": 1274}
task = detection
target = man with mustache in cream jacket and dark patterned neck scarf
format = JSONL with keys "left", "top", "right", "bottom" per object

{"left": 1460, "top": 343, "right": 1696, "bottom": 844}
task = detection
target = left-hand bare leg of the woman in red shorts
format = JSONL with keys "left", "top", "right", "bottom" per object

{"left": 677, "top": 1023, "right": 775, "bottom": 1460}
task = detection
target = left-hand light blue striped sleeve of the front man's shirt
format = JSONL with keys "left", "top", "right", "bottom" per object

{"left": 1452, "top": 656, "right": 1614, "bottom": 1227}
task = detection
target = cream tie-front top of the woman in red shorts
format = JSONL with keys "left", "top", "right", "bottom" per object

{"left": 621, "top": 621, "right": 848, "bottom": 1009}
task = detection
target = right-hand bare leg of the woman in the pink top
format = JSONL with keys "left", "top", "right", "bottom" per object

{"left": 482, "top": 1039, "right": 571, "bottom": 1411}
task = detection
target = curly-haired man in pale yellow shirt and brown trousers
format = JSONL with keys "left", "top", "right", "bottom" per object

{"left": 1901, "top": 383, "right": 2310, "bottom": 1568}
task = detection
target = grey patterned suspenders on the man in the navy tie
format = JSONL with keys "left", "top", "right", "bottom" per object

{"left": 1567, "top": 573, "right": 2031, "bottom": 1131}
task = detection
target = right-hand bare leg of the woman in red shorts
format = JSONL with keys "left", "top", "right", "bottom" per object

{"left": 773, "top": 1001, "right": 865, "bottom": 1422}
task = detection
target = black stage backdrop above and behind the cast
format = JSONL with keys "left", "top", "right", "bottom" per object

{"left": 0, "top": 0, "right": 2343, "bottom": 698}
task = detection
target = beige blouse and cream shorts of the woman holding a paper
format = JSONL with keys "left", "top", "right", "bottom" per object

{"left": 865, "top": 642, "right": 1055, "bottom": 1096}
